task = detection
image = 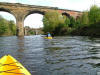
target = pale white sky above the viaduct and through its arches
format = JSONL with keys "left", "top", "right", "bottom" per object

{"left": 0, "top": 0, "right": 100, "bottom": 28}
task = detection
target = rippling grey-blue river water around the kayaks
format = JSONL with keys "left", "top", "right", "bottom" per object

{"left": 0, "top": 35, "right": 100, "bottom": 75}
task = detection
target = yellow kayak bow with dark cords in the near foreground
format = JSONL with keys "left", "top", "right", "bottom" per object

{"left": 0, "top": 55, "right": 31, "bottom": 75}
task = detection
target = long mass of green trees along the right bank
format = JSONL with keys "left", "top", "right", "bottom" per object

{"left": 43, "top": 5, "right": 100, "bottom": 35}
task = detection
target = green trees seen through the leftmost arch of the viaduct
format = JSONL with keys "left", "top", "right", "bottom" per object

{"left": 0, "top": 16, "right": 16, "bottom": 36}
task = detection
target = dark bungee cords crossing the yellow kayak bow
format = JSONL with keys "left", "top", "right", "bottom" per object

{"left": 0, "top": 62, "right": 25, "bottom": 75}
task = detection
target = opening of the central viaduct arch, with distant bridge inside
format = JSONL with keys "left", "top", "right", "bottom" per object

{"left": 24, "top": 13, "right": 43, "bottom": 35}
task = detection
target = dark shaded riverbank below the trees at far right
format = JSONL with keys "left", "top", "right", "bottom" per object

{"left": 70, "top": 24, "right": 100, "bottom": 37}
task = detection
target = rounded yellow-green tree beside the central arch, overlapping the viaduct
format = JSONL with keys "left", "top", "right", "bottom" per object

{"left": 43, "top": 11, "right": 65, "bottom": 33}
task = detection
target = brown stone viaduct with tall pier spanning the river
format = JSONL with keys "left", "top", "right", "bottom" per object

{"left": 0, "top": 2, "right": 82, "bottom": 36}
